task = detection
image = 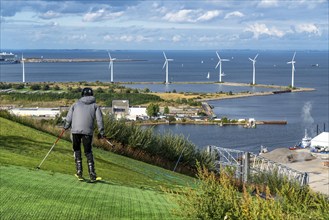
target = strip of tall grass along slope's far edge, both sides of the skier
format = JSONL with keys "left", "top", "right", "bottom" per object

{"left": 0, "top": 110, "right": 212, "bottom": 175}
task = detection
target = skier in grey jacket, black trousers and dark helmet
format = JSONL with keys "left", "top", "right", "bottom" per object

{"left": 64, "top": 88, "right": 104, "bottom": 182}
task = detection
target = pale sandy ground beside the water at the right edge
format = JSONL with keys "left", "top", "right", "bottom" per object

{"left": 262, "top": 148, "right": 329, "bottom": 195}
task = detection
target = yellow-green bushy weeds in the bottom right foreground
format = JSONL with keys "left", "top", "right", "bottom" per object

{"left": 173, "top": 162, "right": 329, "bottom": 220}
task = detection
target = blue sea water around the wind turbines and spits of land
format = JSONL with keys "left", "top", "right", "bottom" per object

{"left": 0, "top": 50, "right": 329, "bottom": 152}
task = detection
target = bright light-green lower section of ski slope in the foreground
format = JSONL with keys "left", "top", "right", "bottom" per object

{"left": 0, "top": 166, "right": 175, "bottom": 219}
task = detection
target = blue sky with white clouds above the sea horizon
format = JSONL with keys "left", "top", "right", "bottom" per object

{"left": 0, "top": 0, "right": 328, "bottom": 50}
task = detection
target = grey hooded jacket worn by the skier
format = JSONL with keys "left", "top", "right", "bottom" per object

{"left": 64, "top": 96, "right": 104, "bottom": 135}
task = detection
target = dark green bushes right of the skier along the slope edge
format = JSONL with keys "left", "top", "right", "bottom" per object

{"left": 104, "top": 116, "right": 211, "bottom": 169}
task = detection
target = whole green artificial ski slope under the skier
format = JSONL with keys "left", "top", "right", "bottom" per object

{"left": 0, "top": 118, "right": 194, "bottom": 219}
